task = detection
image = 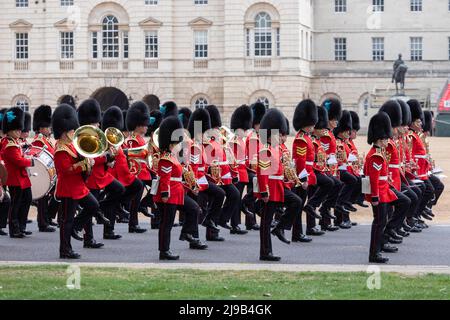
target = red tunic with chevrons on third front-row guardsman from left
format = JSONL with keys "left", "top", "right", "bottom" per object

{"left": 256, "top": 145, "right": 284, "bottom": 202}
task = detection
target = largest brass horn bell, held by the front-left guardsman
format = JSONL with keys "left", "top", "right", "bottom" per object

{"left": 73, "top": 125, "right": 108, "bottom": 159}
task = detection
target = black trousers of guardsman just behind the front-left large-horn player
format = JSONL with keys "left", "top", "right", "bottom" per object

{"left": 91, "top": 179, "right": 125, "bottom": 234}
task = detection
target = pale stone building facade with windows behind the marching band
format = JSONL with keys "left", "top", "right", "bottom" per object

{"left": 0, "top": 0, "right": 450, "bottom": 129}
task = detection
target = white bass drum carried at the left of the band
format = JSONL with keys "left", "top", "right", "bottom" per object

{"left": 25, "top": 146, "right": 56, "bottom": 200}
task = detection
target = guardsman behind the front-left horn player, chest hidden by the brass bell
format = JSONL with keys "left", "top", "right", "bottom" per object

{"left": 78, "top": 99, "right": 121, "bottom": 249}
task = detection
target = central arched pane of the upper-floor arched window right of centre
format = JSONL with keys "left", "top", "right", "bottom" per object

{"left": 255, "top": 12, "right": 272, "bottom": 57}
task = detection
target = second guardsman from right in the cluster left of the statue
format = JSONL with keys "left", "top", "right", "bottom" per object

{"left": 334, "top": 110, "right": 358, "bottom": 229}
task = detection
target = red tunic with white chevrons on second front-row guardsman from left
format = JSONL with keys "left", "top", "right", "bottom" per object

{"left": 154, "top": 152, "right": 184, "bottom": 205}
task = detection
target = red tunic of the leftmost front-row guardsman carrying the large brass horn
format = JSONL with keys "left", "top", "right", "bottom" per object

{"left": 55, "top": 143, "right": 89, "bottom": 200}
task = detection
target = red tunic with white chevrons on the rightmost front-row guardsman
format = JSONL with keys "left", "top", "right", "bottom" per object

{"left": 364, "top": 147, "right": 397, "bottom": 203}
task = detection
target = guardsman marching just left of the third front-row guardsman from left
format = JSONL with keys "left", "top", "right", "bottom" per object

{"left": 228, "top": 105, "right": 259, "bottom": 230}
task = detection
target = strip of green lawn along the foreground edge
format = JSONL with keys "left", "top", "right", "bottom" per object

{"left": 0, "top": 266, "right": 450, "bottom": 300}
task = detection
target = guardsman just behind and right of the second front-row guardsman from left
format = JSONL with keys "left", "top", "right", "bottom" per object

{"left": 188, "top": 109, "right": 225, "bottom": 241}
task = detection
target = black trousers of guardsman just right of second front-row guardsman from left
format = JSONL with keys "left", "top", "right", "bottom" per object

{"left": 198, "top": 181, "right": 226, "bottom": 238}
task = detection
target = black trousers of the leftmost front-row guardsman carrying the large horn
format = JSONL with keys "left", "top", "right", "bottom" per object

{"left": 59, "top": 193, "right": 99, "bottom": 254}
